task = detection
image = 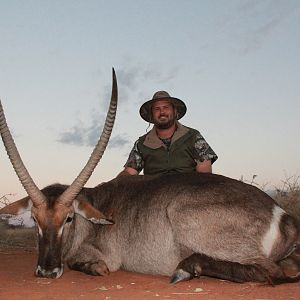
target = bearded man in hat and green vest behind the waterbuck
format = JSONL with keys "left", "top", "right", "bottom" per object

{"left": 118, "top": 91, "right": 218, "bottom": 176}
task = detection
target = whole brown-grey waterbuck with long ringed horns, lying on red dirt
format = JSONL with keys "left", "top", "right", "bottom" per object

{"left": 0, "top": 73, "right": 300, "bottom": 284}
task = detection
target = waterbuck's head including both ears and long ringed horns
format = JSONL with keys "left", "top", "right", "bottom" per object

{"left": 0, "top": 69, "right": 118, "bottom": 278}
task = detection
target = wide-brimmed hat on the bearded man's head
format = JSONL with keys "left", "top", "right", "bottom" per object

{"left": 140, "top": 91, "right": 186, "bottom": 123}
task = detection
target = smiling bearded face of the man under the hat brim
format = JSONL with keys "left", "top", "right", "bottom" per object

{"left": 152, "top": 100, "right": 177, "bottom": 129}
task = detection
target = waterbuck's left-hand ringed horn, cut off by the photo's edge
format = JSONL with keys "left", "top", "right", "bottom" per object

{"left": 0, "top": 101, "right": 45, "bottom": 207}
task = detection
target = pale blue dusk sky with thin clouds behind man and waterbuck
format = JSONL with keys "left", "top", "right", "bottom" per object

{"left": 0, "top": 0, "right": 300, "bottom": 200}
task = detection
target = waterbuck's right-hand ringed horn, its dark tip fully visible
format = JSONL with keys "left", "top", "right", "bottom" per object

{"left": 59, "top": 69, "right": 118, "bottom": 205}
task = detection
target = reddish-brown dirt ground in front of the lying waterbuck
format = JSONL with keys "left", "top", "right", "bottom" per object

{"left": 0, "top": 229, "right": 300, "bottom": 300}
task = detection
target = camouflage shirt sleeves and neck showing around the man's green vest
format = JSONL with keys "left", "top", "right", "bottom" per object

{"left": 124, "top": 123, "right": 218, "bottom": 172}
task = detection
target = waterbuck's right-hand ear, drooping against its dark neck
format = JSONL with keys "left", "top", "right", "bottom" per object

{"left": 73, "top": 195, "right": 115, "bottom": 224}
